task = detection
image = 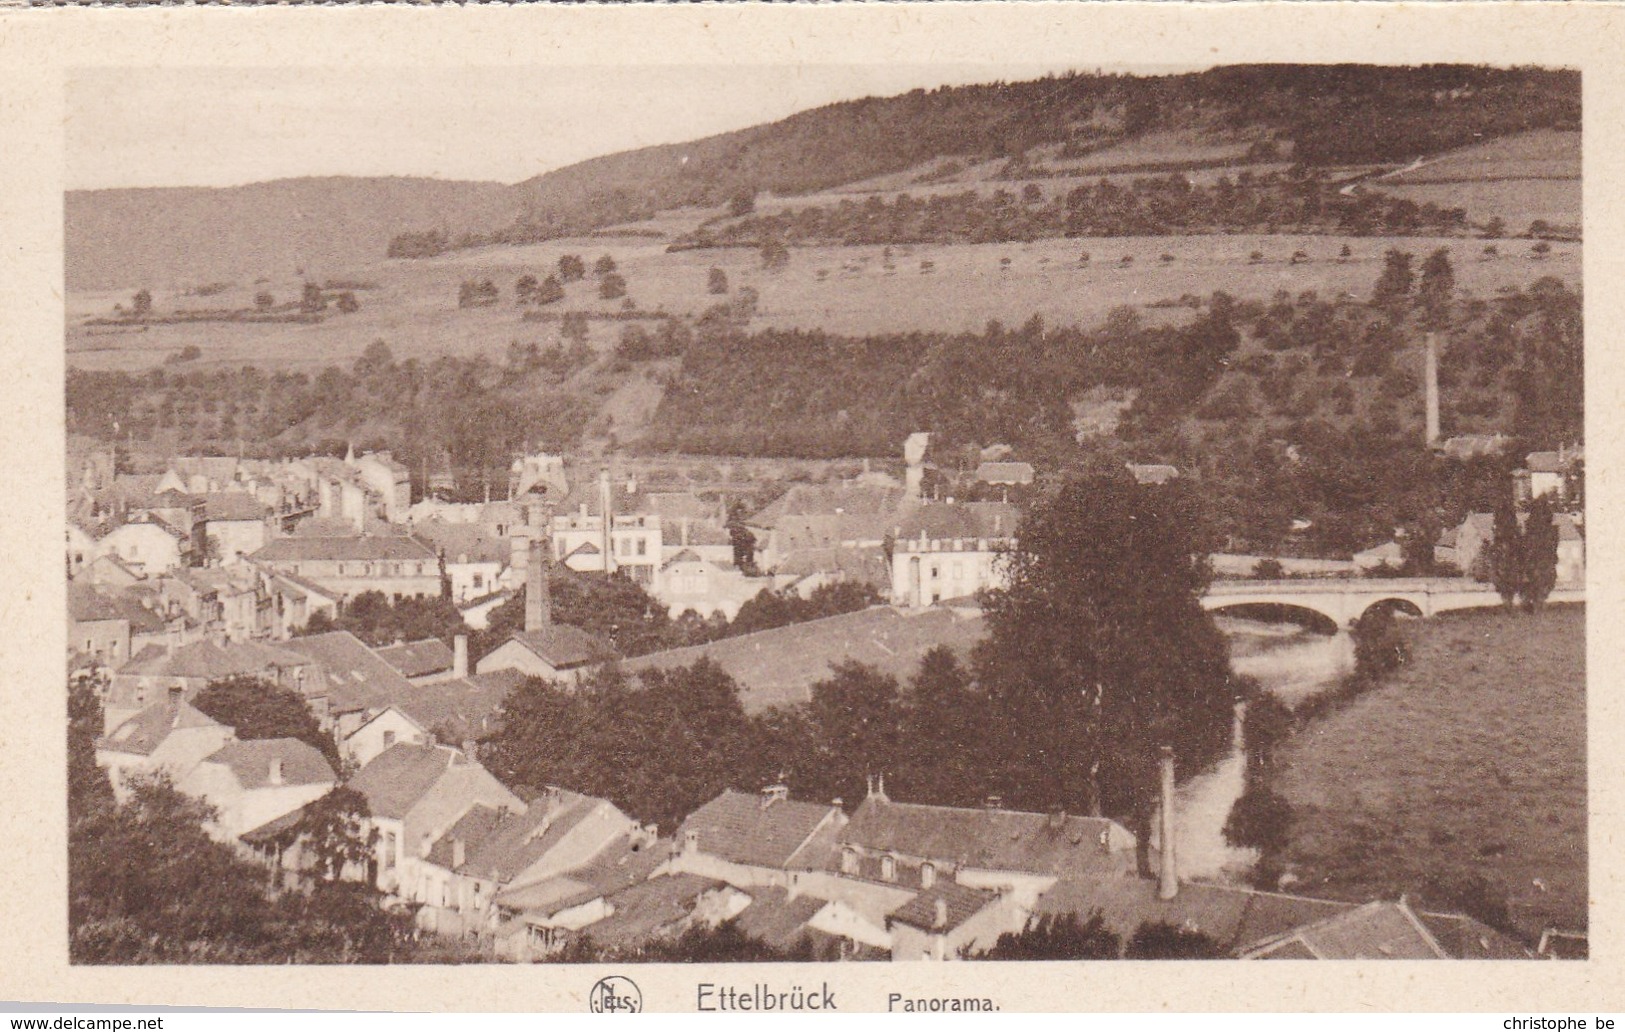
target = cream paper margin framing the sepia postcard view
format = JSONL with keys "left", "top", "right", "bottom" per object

{"left": 0, "top": 3, "right": 1625, "bottom": 1012}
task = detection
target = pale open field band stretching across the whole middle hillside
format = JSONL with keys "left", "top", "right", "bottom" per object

{"left": 67, "top": 236, "right": 1580, "bottom": 369}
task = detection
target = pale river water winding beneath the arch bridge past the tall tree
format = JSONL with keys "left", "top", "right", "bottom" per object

{"left": 1154, "top": 616, "right": 1354, "bottom": 884}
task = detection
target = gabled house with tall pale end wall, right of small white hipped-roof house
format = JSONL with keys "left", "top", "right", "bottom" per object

{"left": 348, "top": 744, "right": 525, "bottom": 902}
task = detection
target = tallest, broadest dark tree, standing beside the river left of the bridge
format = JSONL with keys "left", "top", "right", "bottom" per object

{"left": 975, "top": 473, "right": 1235, "bottom": 865}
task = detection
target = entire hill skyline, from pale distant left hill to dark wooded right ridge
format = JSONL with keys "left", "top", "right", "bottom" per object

{"left": 65, "top": 65, "right": 1580, "bottom": 289}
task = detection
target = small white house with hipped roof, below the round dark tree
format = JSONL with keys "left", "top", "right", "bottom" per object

{"left": 176, "top": 738, "right": 338, "bottom": 842}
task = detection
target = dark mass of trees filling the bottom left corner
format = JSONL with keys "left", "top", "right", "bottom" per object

{"left": 67, "top": 683, "right": 458, "bottom": 964}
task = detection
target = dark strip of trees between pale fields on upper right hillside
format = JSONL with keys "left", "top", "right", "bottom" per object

{"left": 671, "top": 171, "right": 1467, "bottom": 253}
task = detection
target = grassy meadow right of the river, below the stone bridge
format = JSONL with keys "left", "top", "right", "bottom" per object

{"left": 1274, "top": 606, "right": 1586, "bottom": 933}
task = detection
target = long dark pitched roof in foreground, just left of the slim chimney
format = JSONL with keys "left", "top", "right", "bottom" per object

{"left": 840, "top": 796, "right": 1134, "bottom": 878}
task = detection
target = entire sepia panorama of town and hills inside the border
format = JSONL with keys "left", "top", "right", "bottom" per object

{"left": 66, "top": 63, "right": 1588, "bottom": 965}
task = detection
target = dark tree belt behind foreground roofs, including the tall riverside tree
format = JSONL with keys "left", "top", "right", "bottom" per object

{"left": 481, "top": 471, "right": 1237, "bottom": 864}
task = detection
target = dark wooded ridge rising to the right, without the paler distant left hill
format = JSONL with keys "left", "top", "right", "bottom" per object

{"left": 390, "top": 65, "right": 1580, "bottom": 257}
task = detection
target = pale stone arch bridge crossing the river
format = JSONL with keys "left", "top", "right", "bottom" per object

{"left": 1203, "top": 577, "right": 1586, "bottom": 627}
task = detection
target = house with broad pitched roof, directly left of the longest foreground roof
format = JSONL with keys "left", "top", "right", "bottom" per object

{"left": 671, "top": 785, "right": 847, "bottom": 889}
